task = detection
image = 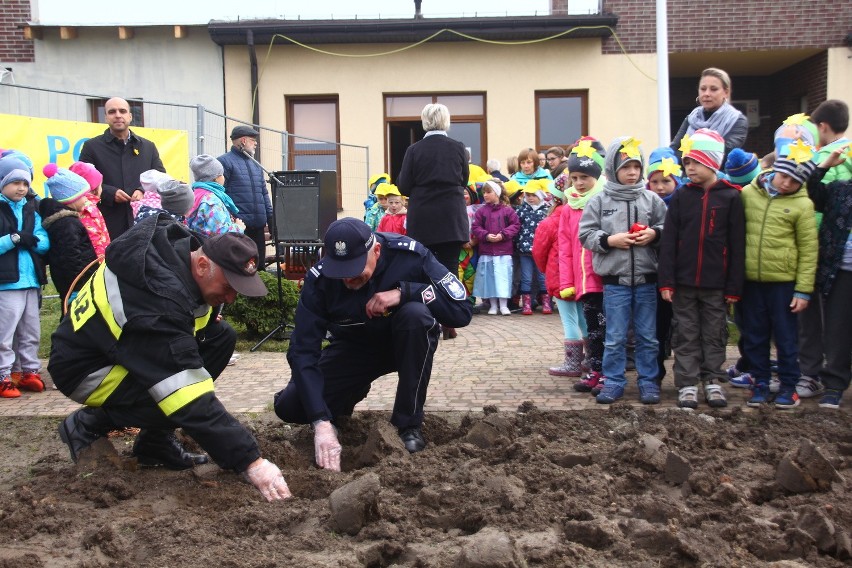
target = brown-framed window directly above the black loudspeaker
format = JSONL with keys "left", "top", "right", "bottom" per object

{"left": 287, "top": 97, "right": 342, "bottom": 203}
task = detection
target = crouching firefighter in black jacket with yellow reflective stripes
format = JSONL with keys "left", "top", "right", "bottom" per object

{"left": 53, "top": 215, "right": 290, "bottom": 501}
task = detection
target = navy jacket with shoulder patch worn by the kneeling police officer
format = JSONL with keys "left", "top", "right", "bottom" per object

{"left": 287, "top": 233, "right": 473, "bottom": 421}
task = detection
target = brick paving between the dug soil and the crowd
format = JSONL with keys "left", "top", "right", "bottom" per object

{"left": 0, "top": 313, "right": 850, "bottom": 416}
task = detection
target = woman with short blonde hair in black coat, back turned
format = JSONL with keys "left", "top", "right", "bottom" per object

{"left": 396, "top": 104, "right": 470, "bottom": 339}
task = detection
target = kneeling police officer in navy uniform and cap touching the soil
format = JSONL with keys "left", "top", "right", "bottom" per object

{"left": 275, "top": 217, "right": 471, "bottom": 471}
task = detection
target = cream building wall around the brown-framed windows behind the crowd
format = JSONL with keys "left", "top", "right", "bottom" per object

{"left": 224, "top": 39, "right": 657, "bottom": 216}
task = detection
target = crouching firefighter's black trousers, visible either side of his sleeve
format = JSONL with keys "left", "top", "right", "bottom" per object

{"left": 101, "top": 320, "right": 237, "bottom": 430}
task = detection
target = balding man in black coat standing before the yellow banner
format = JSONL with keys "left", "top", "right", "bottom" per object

{"left": 80, "top": 97, "right": 166, "bottom": 239}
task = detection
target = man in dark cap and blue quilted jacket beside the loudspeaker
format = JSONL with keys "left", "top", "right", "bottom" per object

{"left": 219, "top": 126, "right": 273, "bottom": 266}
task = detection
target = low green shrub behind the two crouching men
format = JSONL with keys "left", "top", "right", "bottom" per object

{"left": 225, "top": 272, "right": 299, "bottom": 337}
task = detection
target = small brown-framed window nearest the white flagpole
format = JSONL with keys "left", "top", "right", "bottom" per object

{"left": 535, "top": 91, "right": 589, "bottom": 152}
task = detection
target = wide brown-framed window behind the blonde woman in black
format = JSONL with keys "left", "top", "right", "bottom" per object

{"left": 385, "top": 93, "right": 487, "bottom": 179}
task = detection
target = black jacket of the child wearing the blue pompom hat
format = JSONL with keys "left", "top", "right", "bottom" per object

{"left": 38, "top": 197, "right": 98, "bottom": 306}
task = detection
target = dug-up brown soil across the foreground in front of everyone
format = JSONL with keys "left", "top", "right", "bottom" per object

{"left": 0, "top": 404, "right": 852, "bottom": 568}
